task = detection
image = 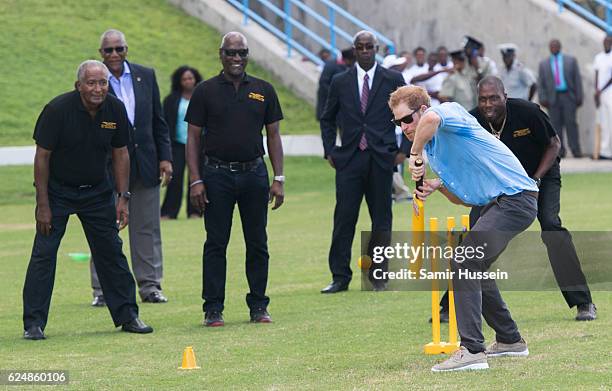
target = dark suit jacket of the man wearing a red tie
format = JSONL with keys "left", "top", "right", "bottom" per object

{"left": 320, "top": 65, "right": 405, "bottom": 170}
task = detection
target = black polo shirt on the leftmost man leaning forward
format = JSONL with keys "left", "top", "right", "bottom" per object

{"left": 33, "top": 90, "right": 128, "bottom": 186}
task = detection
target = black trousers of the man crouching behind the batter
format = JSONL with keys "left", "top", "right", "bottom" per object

{"left": 440, "top": 175, "right": 593, "bottom": 311}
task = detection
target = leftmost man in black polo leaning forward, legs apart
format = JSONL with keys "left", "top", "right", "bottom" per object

{"left": 23, "top": 60, "right": 153, "bottom": 340}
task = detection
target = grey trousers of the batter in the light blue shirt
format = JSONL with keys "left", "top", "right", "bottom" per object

{"left": 453, "top": 192, "right": 538, "bottom": 352}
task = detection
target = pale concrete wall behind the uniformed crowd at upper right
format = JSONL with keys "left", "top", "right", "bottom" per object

{"left": 304, "top": 0, "right": 605, "bottom": 153}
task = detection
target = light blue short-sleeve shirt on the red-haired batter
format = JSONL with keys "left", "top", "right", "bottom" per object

{"left": 425, "top": 102, "right": 538, "bottom": 206}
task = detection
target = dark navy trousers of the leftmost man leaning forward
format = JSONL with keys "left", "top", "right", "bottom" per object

{"left": 23, "top": 181, "right": 138, "bottom": 329}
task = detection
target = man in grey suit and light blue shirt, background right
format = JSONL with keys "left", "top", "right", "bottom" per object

{"left": 538, "top": 39, "right": 582, "bottom": 157}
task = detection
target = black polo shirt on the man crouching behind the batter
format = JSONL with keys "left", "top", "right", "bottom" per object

{"left": 470, "top": 98, "right": 560, "bottom": 177}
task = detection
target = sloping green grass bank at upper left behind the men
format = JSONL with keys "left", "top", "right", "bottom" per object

{"left": 0, "top": 0, "right": 318, "bottom": 146}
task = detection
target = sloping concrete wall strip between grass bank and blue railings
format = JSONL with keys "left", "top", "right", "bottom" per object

{"left": 169, "top": 0, "right": 319, "bottom": 105}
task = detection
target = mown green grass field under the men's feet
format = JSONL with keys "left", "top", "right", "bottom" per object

{"left": 0, "top": 158, "right": 612, "bottom": 390}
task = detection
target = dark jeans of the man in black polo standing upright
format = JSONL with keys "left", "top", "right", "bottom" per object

{"left": 202, "top": 160, "right": 270, "bottom": 312}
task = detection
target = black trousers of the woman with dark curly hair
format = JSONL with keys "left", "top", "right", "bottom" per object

{"left": 161, "top": 142, "right": 199, "bottom": 219}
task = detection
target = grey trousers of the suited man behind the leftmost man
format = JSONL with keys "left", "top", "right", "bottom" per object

{"left": 89, "top": 178, "right": 163, "bottom": 299}
